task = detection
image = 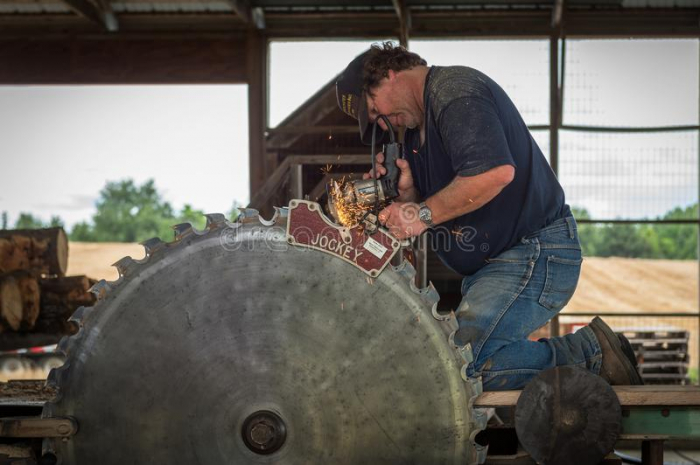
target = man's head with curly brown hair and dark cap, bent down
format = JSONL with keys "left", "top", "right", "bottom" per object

{"left": 336, "top": 42, "right": 426, "bottom": 143}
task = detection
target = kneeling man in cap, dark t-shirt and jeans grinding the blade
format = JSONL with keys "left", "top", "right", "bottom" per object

{"left": 336, "top": 42, "right": 642, "bottom": 390}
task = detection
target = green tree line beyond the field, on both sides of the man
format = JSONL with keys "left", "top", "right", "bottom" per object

{"left": 2, "top": 179, "right": 698, "bottom": 260}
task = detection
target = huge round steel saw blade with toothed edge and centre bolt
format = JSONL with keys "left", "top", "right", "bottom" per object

{"left": 44, "top": 208, "right": 482, "bottom": 465}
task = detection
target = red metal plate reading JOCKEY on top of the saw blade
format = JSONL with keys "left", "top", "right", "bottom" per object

{"left": 287, "top": 200, "right": 400, "bottom": 277}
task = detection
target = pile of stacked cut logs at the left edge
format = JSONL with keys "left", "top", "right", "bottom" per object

{"left": 0, "top": 228, "right": 95, "bottom": 350}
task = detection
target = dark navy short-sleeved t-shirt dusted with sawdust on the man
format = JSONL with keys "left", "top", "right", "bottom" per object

{"left": 405, "top": 66, "right": 571, "bottom": 275}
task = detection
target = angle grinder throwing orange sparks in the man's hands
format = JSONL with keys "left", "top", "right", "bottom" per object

{"left": 326, "top": 115, "right": 403, "bottom": 233}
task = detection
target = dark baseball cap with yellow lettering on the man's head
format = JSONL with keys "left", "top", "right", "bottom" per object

{"left": 335, "top": 50, "right": 384, "bottom": 145}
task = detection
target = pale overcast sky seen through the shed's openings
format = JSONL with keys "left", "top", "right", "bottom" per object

{"left": 0, "top": 39, "right": 699, "bottom": 227}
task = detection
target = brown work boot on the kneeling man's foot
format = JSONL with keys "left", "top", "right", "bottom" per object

{"left": 588, "top": 317, "right": 644, "bottom": 386}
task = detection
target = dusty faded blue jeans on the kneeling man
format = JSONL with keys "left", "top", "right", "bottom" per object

{"left": 455, "top": 217, "right": 601, "bottom": 391}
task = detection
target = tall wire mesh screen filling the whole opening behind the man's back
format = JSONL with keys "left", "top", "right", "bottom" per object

{"left": 556, "top": 40, "right": 700, "bottom": 384}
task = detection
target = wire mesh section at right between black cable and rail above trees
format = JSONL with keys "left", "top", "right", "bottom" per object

{"left": 559, "top": 131, "right": 698, "bottom": 220}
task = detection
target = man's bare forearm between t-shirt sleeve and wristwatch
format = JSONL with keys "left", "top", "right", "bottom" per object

{"left": 422, "top": 165, "right": 515, "bottom": 224}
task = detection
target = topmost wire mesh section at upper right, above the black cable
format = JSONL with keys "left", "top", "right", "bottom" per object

{"left": 563, "top": 39, "right": 698, "bottom": 127}
